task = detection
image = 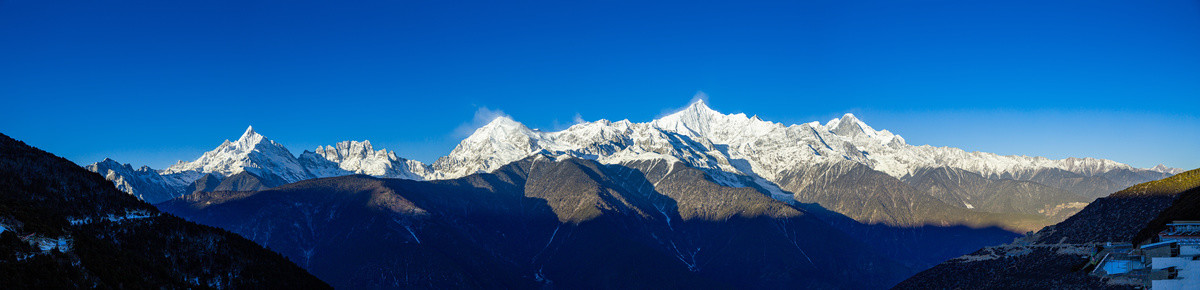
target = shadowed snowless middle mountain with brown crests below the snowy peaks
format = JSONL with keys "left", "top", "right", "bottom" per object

{"left": 160, "top": 155, "right": 912, "bottom": 289}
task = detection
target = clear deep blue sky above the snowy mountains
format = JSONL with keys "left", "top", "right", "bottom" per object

{"left": 0, "top": 0, "right": 1200, "bottom": 168}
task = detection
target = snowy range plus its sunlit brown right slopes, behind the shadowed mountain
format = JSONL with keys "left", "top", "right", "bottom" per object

{"left": 96, "top": 101, "right": 1182, "bottom": 224}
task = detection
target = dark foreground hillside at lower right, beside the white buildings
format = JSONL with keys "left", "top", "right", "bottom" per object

{"left": 896, "top": 169, "right": 1200, "bottom": 289}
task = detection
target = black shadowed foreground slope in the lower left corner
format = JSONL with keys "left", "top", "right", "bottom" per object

{"left": 0, "top": 134, "right": 328, "bottom": 289}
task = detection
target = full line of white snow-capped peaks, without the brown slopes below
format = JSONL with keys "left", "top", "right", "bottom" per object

{"left": 88, "top": 101, "right": 1183, "bottom": 203}
